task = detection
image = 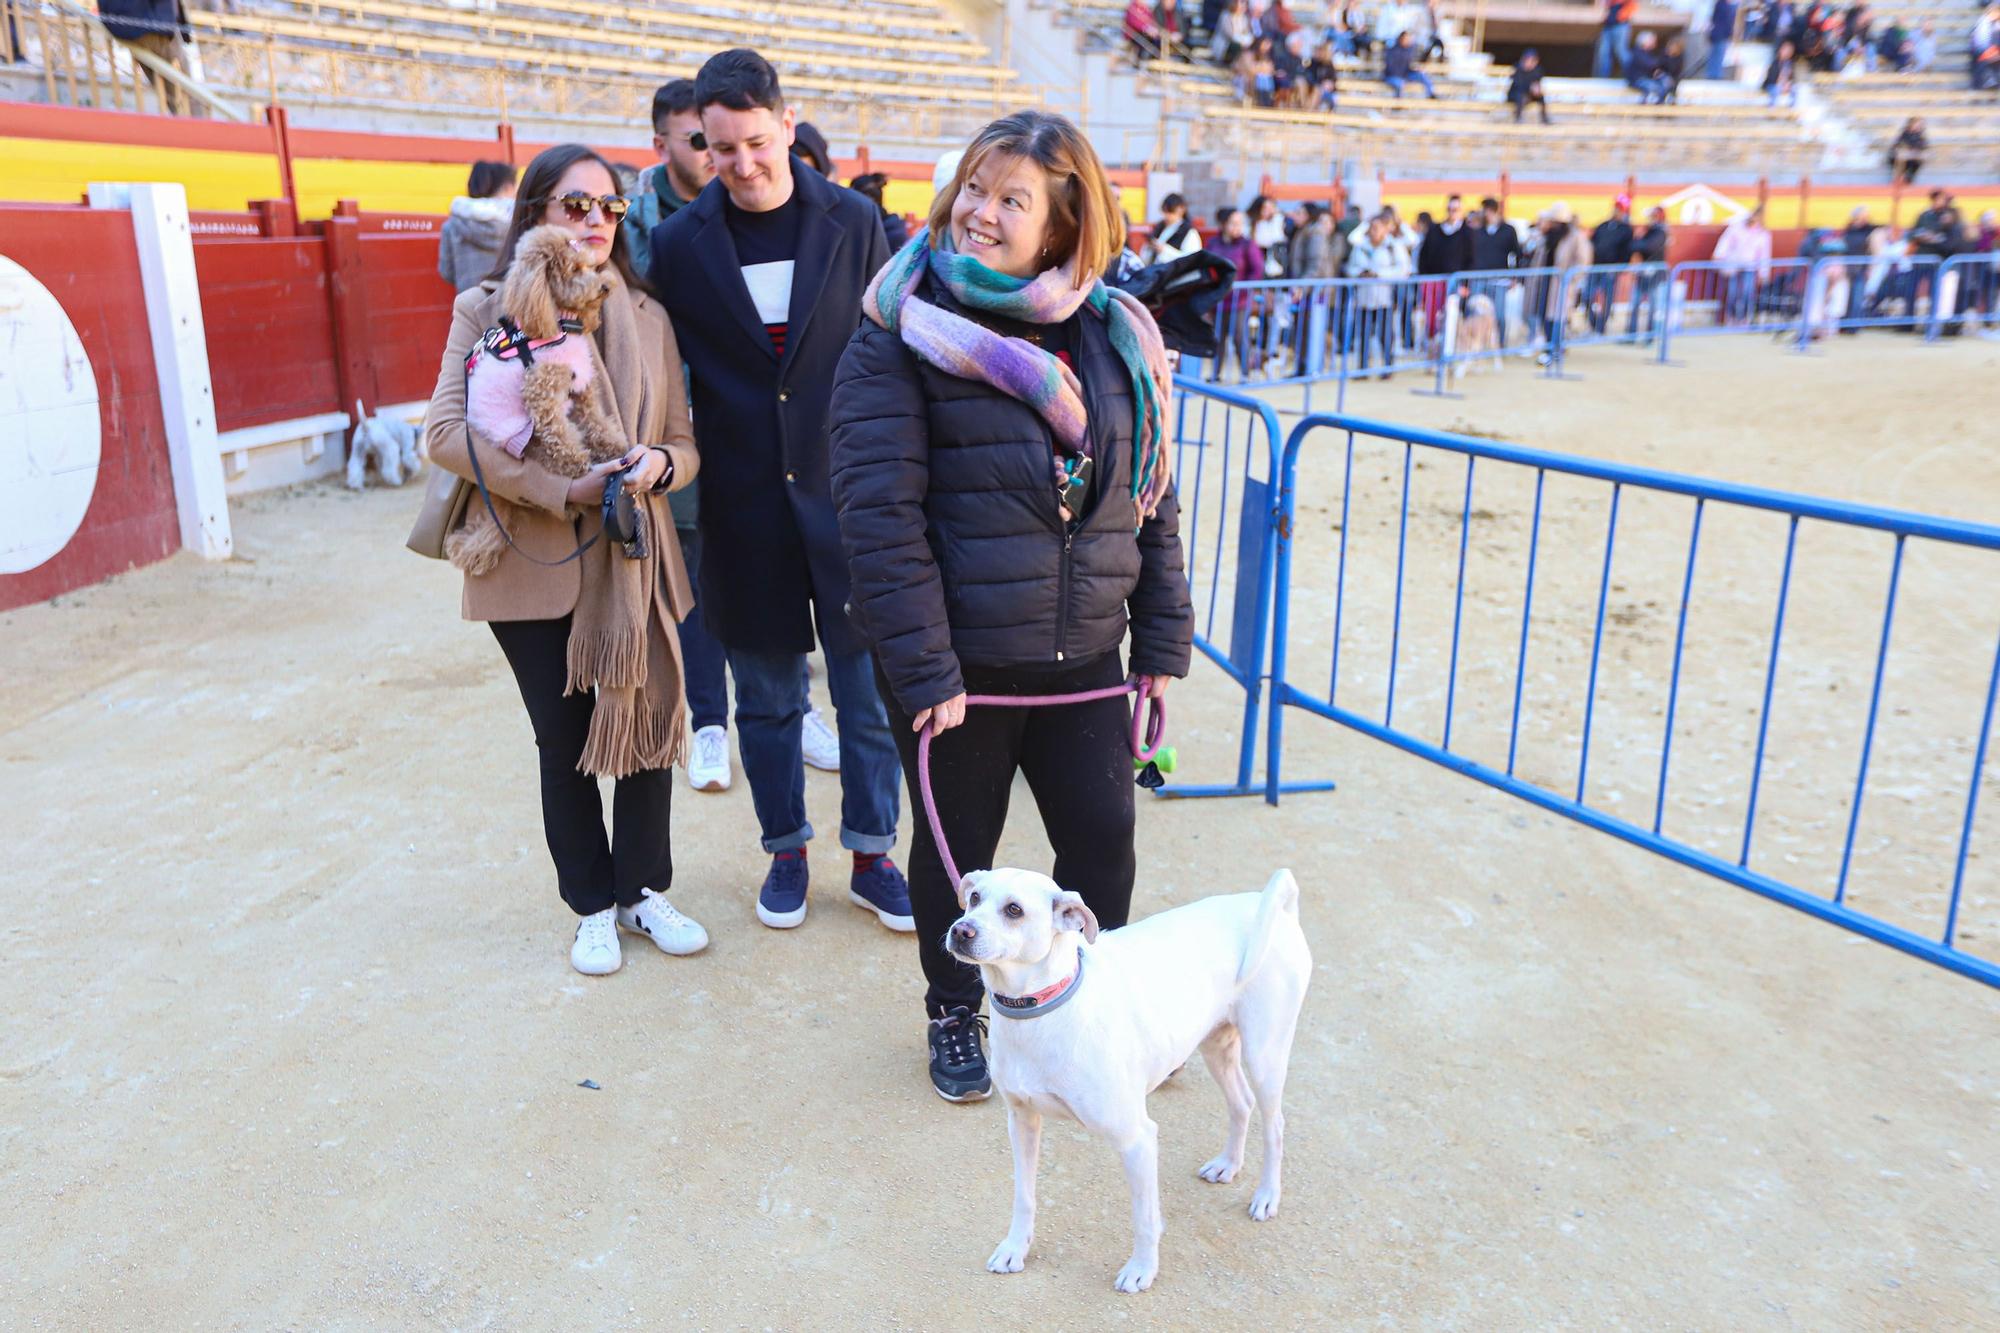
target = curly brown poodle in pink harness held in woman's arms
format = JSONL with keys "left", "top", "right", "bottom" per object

{"left": 444, "top": 226, "right": 626, "bottom": 574}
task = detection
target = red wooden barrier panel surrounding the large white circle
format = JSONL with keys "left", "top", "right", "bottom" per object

{"left": 0, "top": 204, "right": 180, "bottom": 610}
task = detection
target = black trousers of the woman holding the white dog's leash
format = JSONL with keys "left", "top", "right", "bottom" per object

{"left": 876, "top": 652, "right": 1134, "bottom": 1017}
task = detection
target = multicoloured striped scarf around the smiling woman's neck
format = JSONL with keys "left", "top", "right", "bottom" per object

{"left": 862, "top": 232, "right": 1172, "bottom": 526}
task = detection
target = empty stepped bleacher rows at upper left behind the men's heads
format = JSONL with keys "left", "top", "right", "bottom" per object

{"left": 174, "top": 0, "right": 1040, "bottom": 140}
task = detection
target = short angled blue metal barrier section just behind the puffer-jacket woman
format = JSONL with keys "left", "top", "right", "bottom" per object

{"left": 1160, "top": 376, "right": 1332, "bottom": 797}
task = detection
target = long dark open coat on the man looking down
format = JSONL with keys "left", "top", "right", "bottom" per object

{"left": 650, "top": 164, "right": 888, "bottom": 652}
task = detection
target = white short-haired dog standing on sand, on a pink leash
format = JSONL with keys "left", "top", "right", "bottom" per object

{"left": 946, "top": 871, "right": 1312, "bottom": 1291}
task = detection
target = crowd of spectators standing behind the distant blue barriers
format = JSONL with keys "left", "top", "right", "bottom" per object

{"left": 1140, "top": 179, "right": 2000, "bottom": 378}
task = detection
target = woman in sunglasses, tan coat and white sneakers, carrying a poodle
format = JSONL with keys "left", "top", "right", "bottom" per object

{"left": 424, "top": 144, "right": 708, "bottom": 977}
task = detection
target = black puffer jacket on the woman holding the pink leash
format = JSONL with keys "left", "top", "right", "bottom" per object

{"left": 830, "top": 284, "right": 1194, "bottom": 713}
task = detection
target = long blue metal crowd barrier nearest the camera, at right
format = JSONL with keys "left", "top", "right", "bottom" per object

{"left": 1264, "top": 414, "right": 2000, "bottom": 987}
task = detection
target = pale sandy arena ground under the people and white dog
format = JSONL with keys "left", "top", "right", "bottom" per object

{"left": 0, "top": 336, "right": 2000, "bottom": 1329}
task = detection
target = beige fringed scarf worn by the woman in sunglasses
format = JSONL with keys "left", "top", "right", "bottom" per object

{"left": 566, "top": 268, "right": 688, "bottom": 779}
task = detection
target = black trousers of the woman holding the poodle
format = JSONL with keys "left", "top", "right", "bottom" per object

{"left": 490, "top": 616, "right": 674, "bottom": 917}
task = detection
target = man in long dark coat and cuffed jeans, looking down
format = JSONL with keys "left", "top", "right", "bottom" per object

{"left": 652, "top": 50, "right": 914, "bottom": 931}
